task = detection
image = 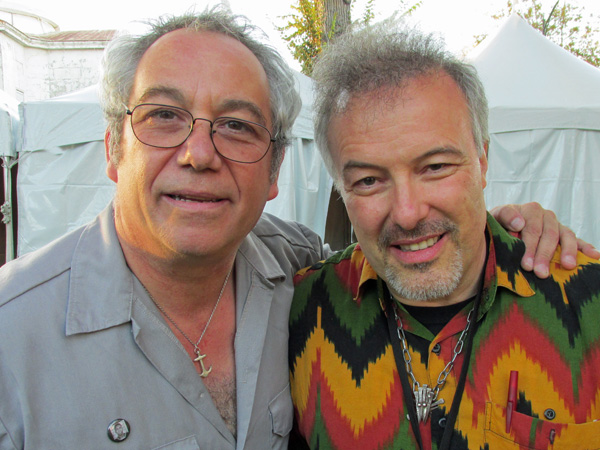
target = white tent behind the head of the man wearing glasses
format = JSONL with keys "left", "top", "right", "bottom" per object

{"left": 17, "top": 73, "right": 332, "bottom": 255}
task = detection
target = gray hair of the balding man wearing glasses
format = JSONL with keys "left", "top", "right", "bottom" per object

{"left": 101, "top": 5, "right": 301, "bottom": 181}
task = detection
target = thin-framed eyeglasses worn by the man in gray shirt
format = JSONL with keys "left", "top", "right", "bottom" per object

{"left": 125, "top": 103, "right": 275, "bottom": 163}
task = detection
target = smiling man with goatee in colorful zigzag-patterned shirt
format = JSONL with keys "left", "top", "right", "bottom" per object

{"left": 289, "top": 20, "right": 600, "bottom": 450}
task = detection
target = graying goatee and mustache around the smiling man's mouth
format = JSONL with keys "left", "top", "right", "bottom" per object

{"left": 379, "top": 219, "right": 464, "bottom": 302}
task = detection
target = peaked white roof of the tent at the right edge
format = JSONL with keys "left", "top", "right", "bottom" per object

{"left": 472, "top": 15, "right": 600, "bottom": 133}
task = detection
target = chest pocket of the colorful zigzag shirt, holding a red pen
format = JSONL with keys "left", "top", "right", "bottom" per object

{"left": 484, "top": 402, "right": 600, "bottom": 450}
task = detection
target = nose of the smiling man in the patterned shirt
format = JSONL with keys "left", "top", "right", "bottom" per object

{"left": 391, "top": 180, "right": 430, "bottom": 230}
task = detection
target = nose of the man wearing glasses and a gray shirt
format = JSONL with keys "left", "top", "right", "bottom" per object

{"left": 178, "top": 118, "right": 221, "bottom": 170}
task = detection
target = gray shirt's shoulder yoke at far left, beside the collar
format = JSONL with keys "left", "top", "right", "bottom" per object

{"left": 0, "top": 225, "right": 86, "bottom": 307}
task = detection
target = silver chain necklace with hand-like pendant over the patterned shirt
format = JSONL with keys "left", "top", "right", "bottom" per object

{"left": 390, "top": 294, "right": 475, "bottom": 423}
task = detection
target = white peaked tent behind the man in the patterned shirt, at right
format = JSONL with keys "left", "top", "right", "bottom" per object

{"left": 473, "top": 16, "right": 600, "bottom": 246}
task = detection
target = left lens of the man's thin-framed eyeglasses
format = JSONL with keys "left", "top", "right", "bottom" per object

{"left": 131, "top": 104, "right": 193, "bottom": 148}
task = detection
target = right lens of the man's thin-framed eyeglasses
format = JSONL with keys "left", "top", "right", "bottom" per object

{"left": 212, "top": 117, "right": 271, "bottom": 162}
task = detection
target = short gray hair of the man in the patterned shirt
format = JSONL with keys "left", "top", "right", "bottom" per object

{"left": 312, "top": 17, "right": 489, "bottom": 183}
